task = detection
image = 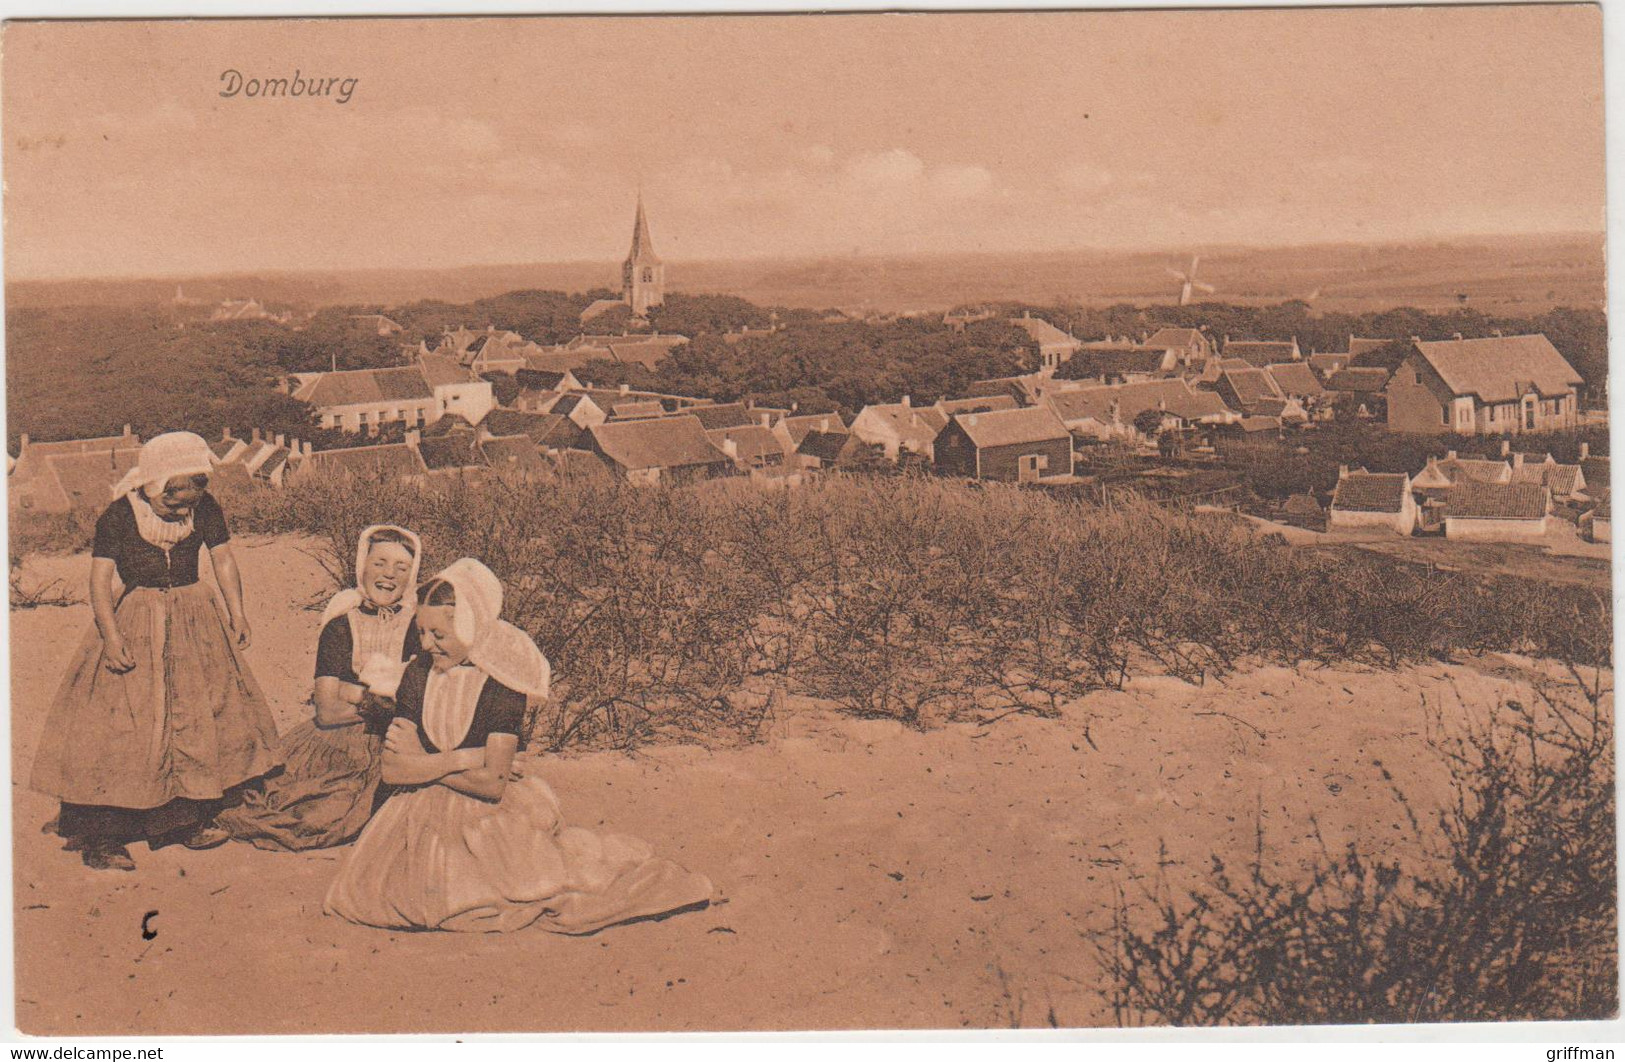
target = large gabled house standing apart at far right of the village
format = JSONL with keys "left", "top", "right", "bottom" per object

{"left": 1384, "top": 335, "right": 1584, "bottom": 435}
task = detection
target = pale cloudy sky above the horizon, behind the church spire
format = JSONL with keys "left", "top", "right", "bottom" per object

{"left": 0, "top": 6, "right": 1604, "bottom": 278}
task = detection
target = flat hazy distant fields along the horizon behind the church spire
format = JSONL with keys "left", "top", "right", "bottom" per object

{"left": 7, "top": 234, "right": 1604, "bottom": 317}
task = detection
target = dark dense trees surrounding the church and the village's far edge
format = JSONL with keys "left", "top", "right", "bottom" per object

{"left": 7, "top": 291, "right": 1607, "bottom": 445}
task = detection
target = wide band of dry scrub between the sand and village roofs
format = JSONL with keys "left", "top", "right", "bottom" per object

{"left": 232, "top": 474, "right": 1610, "bottom": 745}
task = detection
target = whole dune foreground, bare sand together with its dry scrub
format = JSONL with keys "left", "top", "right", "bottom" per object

{"left": 11, "top": 481, "right": 1615, "bottom": 1034}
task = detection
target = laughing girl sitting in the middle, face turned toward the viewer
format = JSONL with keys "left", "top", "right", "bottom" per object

{"left": 216, "top": 525, "right": 423, "bottom": 851}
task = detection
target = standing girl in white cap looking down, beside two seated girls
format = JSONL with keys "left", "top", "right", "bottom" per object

{"left": 33, "top": 432, "right": 276, "bottom": 870}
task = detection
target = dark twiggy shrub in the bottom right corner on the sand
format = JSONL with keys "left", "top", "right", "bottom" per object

{"left": 1100, "top": 687, "right": 1619, "bottom": 1025}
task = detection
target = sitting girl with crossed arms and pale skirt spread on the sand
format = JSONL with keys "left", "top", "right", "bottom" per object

{"left": 327, "top": 559, "right": 712, "bottom": 934}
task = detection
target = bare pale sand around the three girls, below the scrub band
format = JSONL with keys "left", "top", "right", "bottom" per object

{"left": 11, "top": 537, "right": 1610, "bottom": 1036}
